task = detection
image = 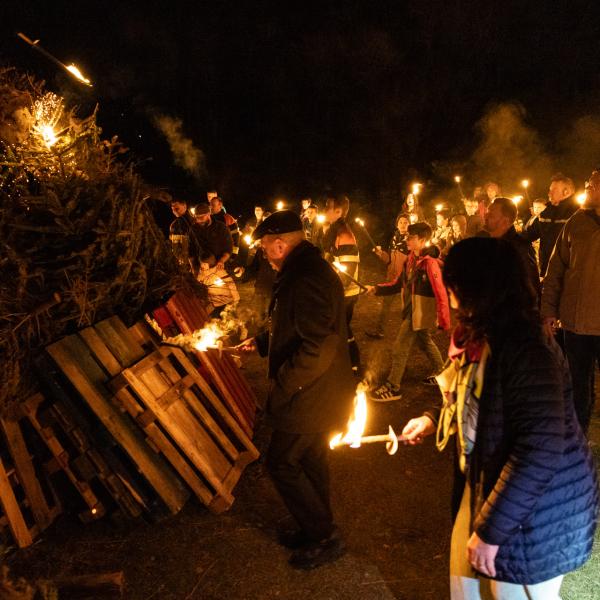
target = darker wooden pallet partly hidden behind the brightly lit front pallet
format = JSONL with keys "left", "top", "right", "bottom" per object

{"left": 47, "top": 317, "right": 189, "bottom": 513}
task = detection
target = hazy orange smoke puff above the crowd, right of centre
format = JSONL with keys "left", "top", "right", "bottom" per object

{"left": 472, "top": 102, "right": 553, "bottom": 188}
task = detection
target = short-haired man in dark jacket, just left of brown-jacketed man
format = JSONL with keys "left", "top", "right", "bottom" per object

{"left": 522, "top": 174, "right": 579, "bottom": 277}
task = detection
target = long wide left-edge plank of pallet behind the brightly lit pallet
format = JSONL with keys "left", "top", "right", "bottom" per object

{"left": 47, "top": 335, "right": 188, "bottom": 513}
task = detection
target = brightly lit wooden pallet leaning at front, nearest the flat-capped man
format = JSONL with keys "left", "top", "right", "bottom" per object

{"left": 110, "top": 347, "right": 259, "bottom": 513}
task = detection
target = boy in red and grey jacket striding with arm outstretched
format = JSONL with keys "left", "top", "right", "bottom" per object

{"left": 369, "top": 223, "right": 450, "bottom": 402}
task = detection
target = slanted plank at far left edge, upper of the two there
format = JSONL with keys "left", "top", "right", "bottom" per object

{"left": 0, "top": 419, "right": 52, "bottom": 529}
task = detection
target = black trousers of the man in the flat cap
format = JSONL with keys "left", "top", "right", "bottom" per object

{"left": 266, "top": 430, "right": 334, "bottom": 541}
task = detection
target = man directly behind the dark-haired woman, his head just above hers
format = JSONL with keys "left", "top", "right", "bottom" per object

{"left": 480, "top": 196, "right": 540, "bottom": 294}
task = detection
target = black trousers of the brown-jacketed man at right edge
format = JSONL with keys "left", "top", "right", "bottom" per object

{"left": 565, "top": 330, "right": 600, "bottom": 435}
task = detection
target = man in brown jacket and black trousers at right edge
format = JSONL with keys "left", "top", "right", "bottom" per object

{"left": 541, "top": 171, "right": 600, "bottom": 433}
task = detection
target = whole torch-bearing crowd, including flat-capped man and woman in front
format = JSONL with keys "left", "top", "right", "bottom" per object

{"left": 162, "top": 171, "right": 600, "bottom": 600}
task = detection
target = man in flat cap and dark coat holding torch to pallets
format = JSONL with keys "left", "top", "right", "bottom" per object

{"left": 244, "top": 211, "right": 356, "bottom": 569}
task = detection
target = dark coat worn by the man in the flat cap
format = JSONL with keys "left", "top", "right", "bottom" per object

{"left": 256, "top": 242, "right": 356, "bottom": 433}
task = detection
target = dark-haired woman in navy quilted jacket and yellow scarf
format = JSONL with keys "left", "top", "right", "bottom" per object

{"left": 403, "top": 238, "right": 598, "bottom": 600}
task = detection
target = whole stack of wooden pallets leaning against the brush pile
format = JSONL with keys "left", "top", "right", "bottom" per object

{"left": 0, "top": 299, "right": 259, "bottom": 547}
